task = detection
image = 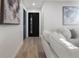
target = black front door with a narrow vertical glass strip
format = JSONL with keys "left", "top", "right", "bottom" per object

{"left": 28, "top": 13, "right": 39, "bottom": 37}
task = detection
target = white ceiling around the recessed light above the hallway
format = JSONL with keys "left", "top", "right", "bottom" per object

{"left": 22, "top": 0, "right": 79, "bottom": 9}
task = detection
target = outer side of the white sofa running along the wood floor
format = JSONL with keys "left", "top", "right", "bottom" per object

{"left": 41, "top": 35, "right": 58, "bottom": 58}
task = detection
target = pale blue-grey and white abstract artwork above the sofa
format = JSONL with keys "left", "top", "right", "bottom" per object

{"left": 63, "top": 6, "right": 79, "bottom": 25}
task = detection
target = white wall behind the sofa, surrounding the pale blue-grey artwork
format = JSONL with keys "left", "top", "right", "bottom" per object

{"left": 42, "top": 1, "right": 79, "bottom": 30}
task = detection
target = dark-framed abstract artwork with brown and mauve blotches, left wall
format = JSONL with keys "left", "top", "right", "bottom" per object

{"left": 0, "top": 0, "right": 20, "bottom": 25}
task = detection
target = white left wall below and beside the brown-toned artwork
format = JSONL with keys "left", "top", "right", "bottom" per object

{"left": 0, "top": 0, "right": 23, "bottom": 58}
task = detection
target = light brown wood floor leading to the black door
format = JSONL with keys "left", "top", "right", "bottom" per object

{"left": 16, "top": 38, "right": 46, "bottom": 58}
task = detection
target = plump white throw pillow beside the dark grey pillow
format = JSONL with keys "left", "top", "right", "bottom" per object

{"left": 57, "top": 27, "right": 71, "bottom": 39}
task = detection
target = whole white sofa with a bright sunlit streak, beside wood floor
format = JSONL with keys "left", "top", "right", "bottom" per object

{"left": 41, "top": 31, "right": 79, "bottom": 58}
